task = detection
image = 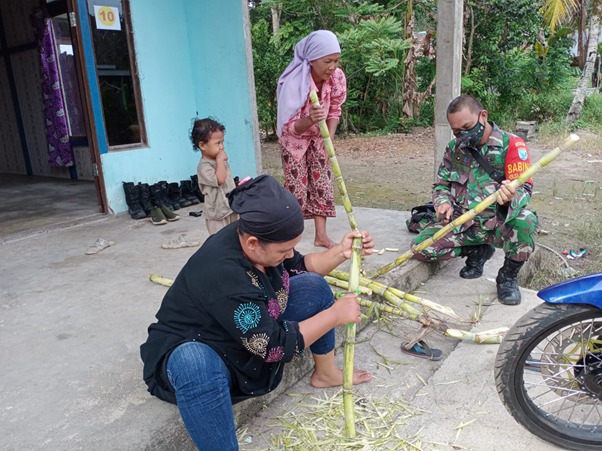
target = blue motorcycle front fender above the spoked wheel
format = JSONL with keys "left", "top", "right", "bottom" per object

{"left": 537, "top": 273, "right": 602, "bottom": 309}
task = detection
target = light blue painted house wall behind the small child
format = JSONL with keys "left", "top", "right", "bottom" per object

{"left": 101, "top": 0, "right": 256, "bottom": 213}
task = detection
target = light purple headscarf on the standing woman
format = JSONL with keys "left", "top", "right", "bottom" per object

{"left": 277, "top": 30, "right": 341, "bottom": 136}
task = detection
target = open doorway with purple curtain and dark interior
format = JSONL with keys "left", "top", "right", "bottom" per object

{"left": 0, "top": 0, "right": 106, "bottom": 241}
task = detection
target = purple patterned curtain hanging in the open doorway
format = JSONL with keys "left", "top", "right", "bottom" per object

{"left": 32, "top": 11, "right": 75, "bottom": 167}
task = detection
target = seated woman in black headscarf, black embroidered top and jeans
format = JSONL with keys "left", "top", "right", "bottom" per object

{"left": 140, "top": 175, "right": 373, "bottom": 450}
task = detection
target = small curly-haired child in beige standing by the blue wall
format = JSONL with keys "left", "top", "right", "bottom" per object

{"left": 190, "top": 118, "right": 238, "bottom": 235}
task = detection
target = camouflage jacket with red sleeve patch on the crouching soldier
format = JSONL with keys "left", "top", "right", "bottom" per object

{"left": 433, "top": 123, "right": 533, "bottom": 233}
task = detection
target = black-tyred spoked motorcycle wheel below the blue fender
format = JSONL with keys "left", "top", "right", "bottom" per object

{"left": 495, "top": 304, "right": 602, "bottom": 450}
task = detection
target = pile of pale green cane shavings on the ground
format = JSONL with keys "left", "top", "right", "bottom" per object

{"left": 270, "top": 390, "right": 423, "bottom": 451}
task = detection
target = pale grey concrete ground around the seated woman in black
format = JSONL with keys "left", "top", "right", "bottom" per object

{"left": 0, "top": 206, "right": 560, "bottom": 450}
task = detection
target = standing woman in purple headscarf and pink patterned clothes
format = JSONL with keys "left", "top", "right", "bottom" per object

{"left": 277, "top": 30, "right": 347, "bottom": 248}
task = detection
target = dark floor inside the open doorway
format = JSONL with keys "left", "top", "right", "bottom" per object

{"left": 0, "top": 174, "right": 101, "bottom": 243}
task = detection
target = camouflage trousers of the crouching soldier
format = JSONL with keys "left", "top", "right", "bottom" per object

{"left": 412, "top": 210, "right": 537, "bottom": 261}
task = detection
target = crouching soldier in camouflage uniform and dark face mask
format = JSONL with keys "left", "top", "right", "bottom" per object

{"left": 413, "top": 96, "right": 537, "bottom": 305}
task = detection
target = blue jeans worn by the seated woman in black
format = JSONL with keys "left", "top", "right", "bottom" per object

{"left": 167, "top": 273, "right": 335, "bottom": 451}
